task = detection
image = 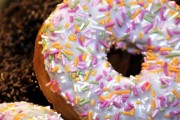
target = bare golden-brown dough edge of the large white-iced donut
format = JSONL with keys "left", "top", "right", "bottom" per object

{"left": 33, "top": 25, "right": 80, "bottom": 120}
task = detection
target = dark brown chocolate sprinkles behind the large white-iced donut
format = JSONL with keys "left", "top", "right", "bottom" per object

{"left": 0, "top": 0, "right": 61, "bottom": 105}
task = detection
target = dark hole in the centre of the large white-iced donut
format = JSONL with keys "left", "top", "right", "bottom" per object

{"left": 107, "top": 47, "right": 144, "bottom": 77}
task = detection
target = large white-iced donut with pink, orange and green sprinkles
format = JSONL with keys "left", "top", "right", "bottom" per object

{"left": 34, "top": 0, "right": 180, "bottom": 120}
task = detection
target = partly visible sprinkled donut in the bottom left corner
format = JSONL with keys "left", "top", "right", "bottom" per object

{"left": 0, "top": 101, "right": 63, "bottom": 120}
